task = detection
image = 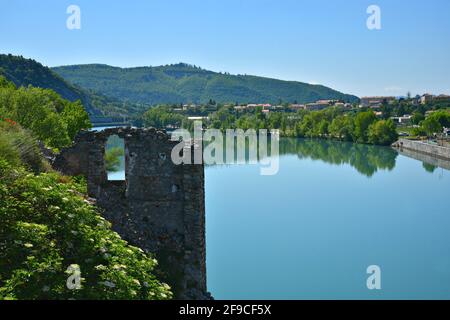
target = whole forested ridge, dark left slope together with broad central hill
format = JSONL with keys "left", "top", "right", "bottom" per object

{"left": 0, "top": 54, "right": 358, "bottom": 122}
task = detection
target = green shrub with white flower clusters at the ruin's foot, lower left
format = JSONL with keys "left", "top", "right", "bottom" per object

{"left": 0, "top": 160, "right": 172, "bottom": 299}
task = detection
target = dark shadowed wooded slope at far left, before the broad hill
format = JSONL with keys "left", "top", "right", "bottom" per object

{"left": 0, "top": 54, "right": 98, "bottom": 114}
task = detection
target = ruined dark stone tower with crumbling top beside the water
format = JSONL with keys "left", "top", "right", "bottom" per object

{"left": 54, "top": 128, "right": 208, "bottom": 299}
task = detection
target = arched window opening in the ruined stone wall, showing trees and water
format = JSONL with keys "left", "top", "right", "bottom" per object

{"left": 105, "top": 135, "right": 125, "bottom": 181}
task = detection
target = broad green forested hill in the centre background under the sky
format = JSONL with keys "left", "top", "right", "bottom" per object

{"left": 53, "top": 63, "right": 358, "bottom": 104}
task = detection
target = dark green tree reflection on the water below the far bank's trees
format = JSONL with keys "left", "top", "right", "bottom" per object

{"left": 280, "top": 138, "right": 398, "bottom": 177}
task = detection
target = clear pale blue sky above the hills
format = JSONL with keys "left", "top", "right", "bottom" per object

{"left": 0, "top": 0, "right": 450, "bottom": 96}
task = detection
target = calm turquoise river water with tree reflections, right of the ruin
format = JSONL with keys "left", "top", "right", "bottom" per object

{"left": 105, "top": 138, "right": 450, "bottom": 299}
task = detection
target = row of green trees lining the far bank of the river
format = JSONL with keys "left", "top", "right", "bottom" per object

{"left": 143, "top": 104, "right": 398, "bottom": 145}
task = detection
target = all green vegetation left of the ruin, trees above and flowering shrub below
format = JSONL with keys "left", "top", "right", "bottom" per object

{"left": 0, "top": 77, "right": 172, "bottom": 300}
